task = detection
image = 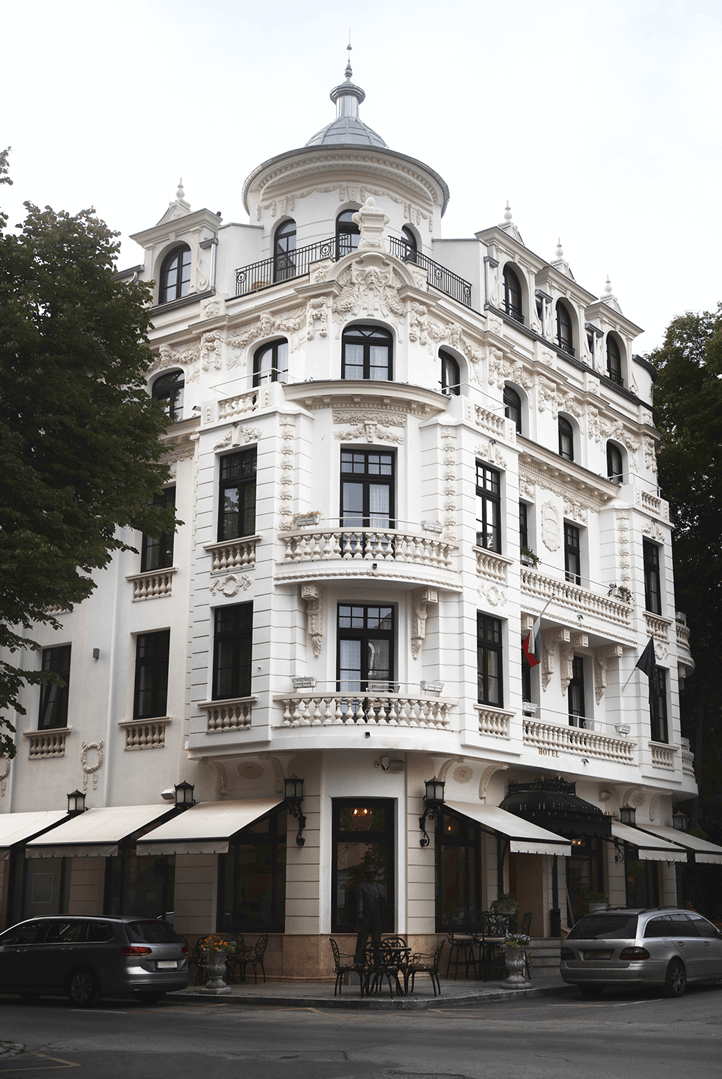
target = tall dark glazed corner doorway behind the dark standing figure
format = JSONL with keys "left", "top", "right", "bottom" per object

{"left": 331, "top": 798, "right": 395, "bottom": 933}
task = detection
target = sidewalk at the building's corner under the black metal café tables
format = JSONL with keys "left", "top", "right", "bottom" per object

{"left": 166, "top": 973, "right": 574, "bottom": 1011}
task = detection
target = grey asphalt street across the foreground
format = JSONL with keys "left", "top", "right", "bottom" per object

{"left": 0, "top": 987, "right": 722, "bottom": 1079}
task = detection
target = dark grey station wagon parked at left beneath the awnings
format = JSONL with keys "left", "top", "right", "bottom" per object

{"left": 0, "top": 915, "right": 189, "bottom": 1008}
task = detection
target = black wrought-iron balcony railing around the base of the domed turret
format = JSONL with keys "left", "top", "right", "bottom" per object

{"left": 235, "top": 236, "right": 472, "bottom": 308}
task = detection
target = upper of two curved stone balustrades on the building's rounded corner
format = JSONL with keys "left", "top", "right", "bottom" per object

{"left": 281, "top": 527, "right": 459, "bottom": 570}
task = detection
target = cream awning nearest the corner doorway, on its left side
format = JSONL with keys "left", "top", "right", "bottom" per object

{"left": 136, "top": 797, "right": 284, "bottom": 855}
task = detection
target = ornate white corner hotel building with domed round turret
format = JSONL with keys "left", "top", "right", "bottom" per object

{"left": 0, "top": 59, "right": 722, "bottom": 978}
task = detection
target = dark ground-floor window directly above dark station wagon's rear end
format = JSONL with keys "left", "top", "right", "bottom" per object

{"left": 103, "top": 849, "right": 176, "bottom": 918}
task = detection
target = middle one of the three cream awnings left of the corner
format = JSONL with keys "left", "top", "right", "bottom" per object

{"left": 25, "top": 805, "right": 175, "bottom": 858}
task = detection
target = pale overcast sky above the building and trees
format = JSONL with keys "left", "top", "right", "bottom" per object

{"left": 0, "top": 0, "right": 722, "bottom": 352}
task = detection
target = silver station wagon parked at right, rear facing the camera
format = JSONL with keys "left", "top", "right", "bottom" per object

{"left": 559, "top": 906, "right": 722, "bottom": 997}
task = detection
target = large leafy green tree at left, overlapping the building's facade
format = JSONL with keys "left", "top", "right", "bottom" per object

{"left": 0, "top": 151, "right": 175, "bottom": 756}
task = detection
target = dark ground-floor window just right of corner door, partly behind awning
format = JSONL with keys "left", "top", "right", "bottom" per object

{"left": 436, "top": 811, "right": 481, "bottom": 932}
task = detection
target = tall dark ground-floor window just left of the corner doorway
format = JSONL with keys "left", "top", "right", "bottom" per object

{"left": 217, "top": 809, "right": 287, "bottom": 933}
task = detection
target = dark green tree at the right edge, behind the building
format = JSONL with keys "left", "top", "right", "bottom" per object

{"left": 649, "top": 304, "right": 722, "bottom": 837}
